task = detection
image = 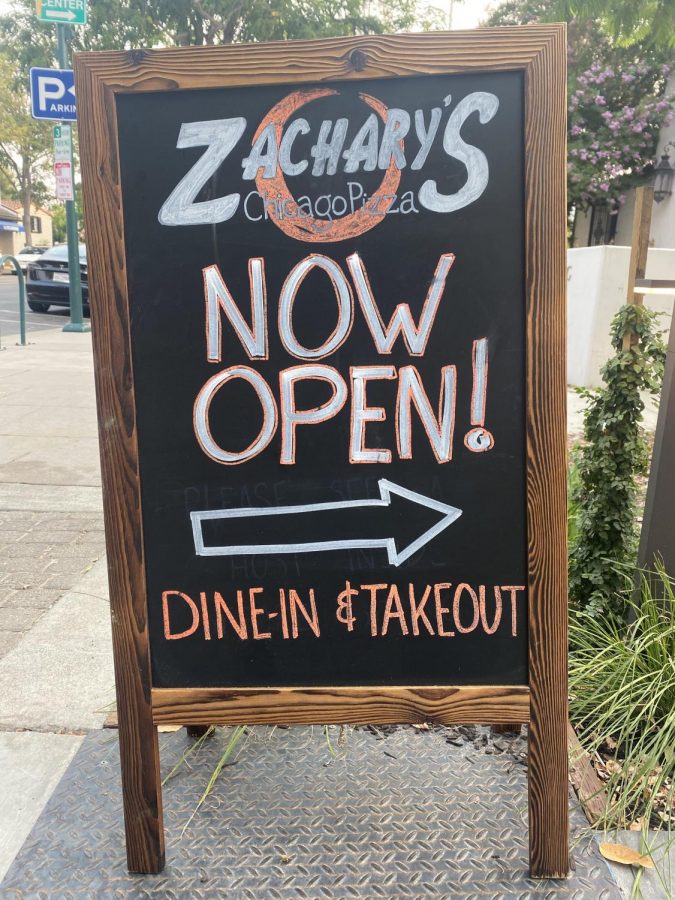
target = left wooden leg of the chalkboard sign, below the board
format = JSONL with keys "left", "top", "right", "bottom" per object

{"left": 119, "top": 703, "right": 164, "bottom": 875}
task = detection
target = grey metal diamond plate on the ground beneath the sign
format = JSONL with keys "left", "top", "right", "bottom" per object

{"left": 0, "top": 727, "right": 620, "bottom": 900}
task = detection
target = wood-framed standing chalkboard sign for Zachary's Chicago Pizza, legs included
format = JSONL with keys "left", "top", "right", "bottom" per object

{"left": 77, "top": 26, "right": 567, "bottom": 874}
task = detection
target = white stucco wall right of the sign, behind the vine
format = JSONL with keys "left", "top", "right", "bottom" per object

{"left": 567, "top": 245, "right": 675, "bottom": 387}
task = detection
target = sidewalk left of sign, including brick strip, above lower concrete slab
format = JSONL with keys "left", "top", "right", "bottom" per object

{"left": 0, "top": 331, "right": 105, "bottom": 658}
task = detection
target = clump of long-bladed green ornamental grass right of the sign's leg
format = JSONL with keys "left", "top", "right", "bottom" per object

{"left": 569, "top": 565, "right": 675, "bottom": 830}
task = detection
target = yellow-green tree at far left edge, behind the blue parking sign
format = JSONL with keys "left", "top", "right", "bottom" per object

{"left": 0, "top": 56, "right": 51, "bottom": 244}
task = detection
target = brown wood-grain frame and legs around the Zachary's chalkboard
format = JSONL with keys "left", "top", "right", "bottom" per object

{"left": 75, "top": 24, "right": 569, "bottom": 878}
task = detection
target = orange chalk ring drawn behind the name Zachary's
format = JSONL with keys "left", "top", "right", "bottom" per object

{"left": 253, "top": 88, "right": 403, "bottom": 243}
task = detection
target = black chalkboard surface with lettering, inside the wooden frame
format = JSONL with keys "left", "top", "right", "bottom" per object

{"left": 116, "top": 71, "right": 528, "bottom": 687}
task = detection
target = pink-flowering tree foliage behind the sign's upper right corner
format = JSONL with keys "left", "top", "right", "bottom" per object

{"left": 488, "top": 0, "right": 673, "bottom": 209}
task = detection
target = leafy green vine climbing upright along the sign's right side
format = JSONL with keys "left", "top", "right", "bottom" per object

{"left": 569, "top": 305, "right": 665, "bottom": 621}
